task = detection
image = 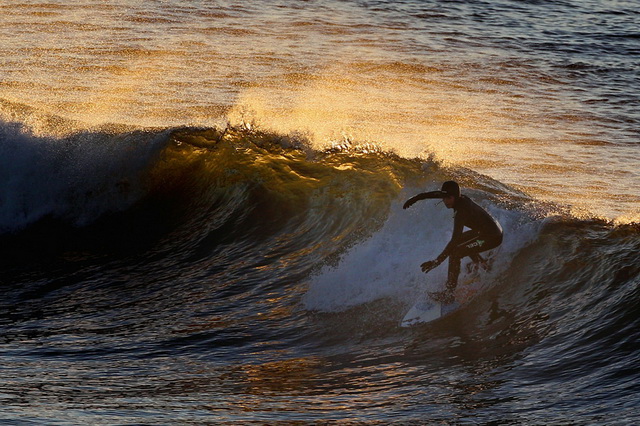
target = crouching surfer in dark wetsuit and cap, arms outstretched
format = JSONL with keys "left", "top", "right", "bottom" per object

{"left": 402, "top": 181, "right": 502, "bottom": 303}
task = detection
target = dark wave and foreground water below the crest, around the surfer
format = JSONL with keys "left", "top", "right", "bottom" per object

{"left": 0, "top": 123, "right": 640, "bottom": 423}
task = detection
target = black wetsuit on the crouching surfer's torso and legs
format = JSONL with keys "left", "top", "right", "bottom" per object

{"left": 438, "top": 195, "right": 502, "bottom": 290}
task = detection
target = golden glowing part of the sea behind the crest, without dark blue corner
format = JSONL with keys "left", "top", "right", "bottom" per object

{"left": 0, "top": 1, "right": 639, "bottom": 221}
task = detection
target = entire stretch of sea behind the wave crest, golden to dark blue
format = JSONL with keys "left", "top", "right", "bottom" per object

{"left": 0, "top": 1, "right": 640, "bottom": 220}
